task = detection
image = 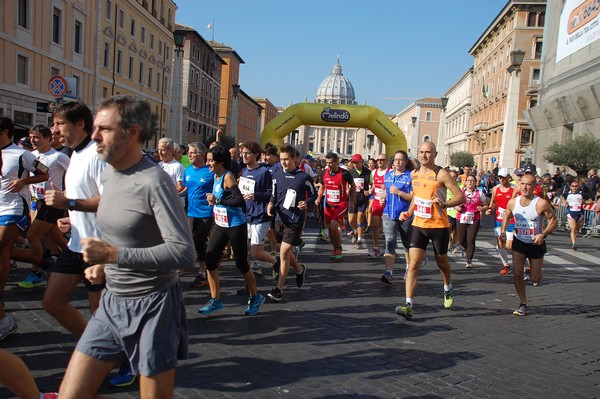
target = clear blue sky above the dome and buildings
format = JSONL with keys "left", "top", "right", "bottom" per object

{"left": 175, "top": 0, "right": 507, "bottom": 114}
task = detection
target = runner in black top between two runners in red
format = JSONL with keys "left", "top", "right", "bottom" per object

{"left": 348, "top": 154, "right": 371, "bottom": 249}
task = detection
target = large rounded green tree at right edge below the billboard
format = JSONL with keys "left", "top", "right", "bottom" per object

{"left": 544, "top": 134, "right": 600, "bottom": 177}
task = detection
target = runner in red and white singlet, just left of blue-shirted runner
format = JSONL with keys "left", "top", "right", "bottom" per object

{"left": 369, "top": 153, "right": 392, "bottom": 257}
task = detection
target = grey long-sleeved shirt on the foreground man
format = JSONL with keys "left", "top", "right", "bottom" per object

{"left": 98, "top": 158, "right": 194, "bottom": 297}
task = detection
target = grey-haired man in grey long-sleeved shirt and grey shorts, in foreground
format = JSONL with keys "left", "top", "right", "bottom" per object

{"left": 59, "top": 96, "right": 194, "bottom": 399}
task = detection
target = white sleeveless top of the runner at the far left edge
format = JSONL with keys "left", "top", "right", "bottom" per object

{"left": 0, "top": 144, "right": 35, "bottom": 216}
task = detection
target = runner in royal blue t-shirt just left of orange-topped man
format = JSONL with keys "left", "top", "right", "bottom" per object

{"left": 380, "top": 150, "right": 415, "bottom": 284}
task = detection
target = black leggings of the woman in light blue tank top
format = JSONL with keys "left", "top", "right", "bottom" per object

{"left": 206, "top": 223, "right": 250, "bottom": 274}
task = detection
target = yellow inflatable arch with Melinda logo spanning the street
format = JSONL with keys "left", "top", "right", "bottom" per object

{"left": 260, "top": 103, "right": 406, "bottom": 157}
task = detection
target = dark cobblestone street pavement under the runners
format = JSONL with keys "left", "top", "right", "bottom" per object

{"left": 0, "top": 218, "right": 600, "bottom": 399}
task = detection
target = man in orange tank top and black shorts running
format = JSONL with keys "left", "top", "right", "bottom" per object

{"left": 396, "top": 141, "right": 465, "bottom": 320}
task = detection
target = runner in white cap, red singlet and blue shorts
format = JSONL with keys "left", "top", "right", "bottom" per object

{"left": 486, "top": 168, "right": 515, "bottom": 275}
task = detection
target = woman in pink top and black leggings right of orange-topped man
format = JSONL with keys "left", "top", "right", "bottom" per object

{"left": 456, "top": 175, "right": 488, "bottom": 269}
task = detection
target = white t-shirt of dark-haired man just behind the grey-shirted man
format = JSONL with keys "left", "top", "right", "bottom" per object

{"left": 65, "top": 141, "right": 105, "bottom": 253}
